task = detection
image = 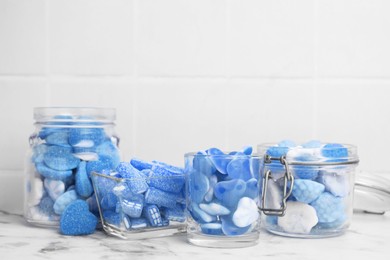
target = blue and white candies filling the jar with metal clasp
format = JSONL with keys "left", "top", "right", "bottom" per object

{"left": 266, "top": 140, "right": 353, "bottom": 234}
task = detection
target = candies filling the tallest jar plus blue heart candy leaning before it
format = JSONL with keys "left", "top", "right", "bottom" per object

{"left": 25, "top": 122, "right": 120, "bottom": 235}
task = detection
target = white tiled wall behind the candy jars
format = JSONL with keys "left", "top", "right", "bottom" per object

{"left": 0, "top": 0, "right": 390, "bottom": 213}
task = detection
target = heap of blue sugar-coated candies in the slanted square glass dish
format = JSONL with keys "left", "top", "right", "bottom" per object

{"left": 93, "top": 158, "right": 185, "bottom": 231}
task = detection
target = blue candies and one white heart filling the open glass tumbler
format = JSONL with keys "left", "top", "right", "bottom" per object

{"left": 186, "top": 147, "right": 259, "bottom": 236}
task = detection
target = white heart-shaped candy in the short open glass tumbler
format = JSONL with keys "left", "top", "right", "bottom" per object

{"left": 232, "top": 197, "right": 259, "bottom": 227}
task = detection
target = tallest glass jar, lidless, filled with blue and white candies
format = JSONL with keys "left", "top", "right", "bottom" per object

{"left": 24, "top": 107, "right": 120, "bottom": 227}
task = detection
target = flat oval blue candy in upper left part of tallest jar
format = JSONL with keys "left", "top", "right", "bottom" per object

{"left": 43, "top": 146, "right": 80, "bottom": 171}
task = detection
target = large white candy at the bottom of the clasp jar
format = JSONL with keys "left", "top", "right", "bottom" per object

{"left": 278, "top": 201, "right": 318, "bottom": 234}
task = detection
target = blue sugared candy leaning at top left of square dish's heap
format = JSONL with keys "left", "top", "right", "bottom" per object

{"left": 116, "top": 162, "right": 149, "bottom": 194}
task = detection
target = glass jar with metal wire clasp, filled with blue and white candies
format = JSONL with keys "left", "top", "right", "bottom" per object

{"left": 258, "top": 142, "right": 359, "bottom": 238}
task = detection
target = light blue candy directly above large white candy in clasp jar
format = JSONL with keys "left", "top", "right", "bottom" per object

{"left": 292, "top": 179, "right": 325, "bottom": 204}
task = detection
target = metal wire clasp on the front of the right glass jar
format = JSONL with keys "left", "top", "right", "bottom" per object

{"left": 260, "top": 154, "right": 294, "bottom": 217}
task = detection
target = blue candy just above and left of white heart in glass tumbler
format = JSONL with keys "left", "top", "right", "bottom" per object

{"left": 214, "top": 179, "right": 246, "bottom": 209}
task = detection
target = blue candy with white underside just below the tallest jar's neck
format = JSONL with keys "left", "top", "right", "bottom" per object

{"left": 69, "top": 128, "right": 106, "bottom": 147}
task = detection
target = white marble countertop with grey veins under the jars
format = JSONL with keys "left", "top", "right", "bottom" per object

{"left": 0, "top": 211, "right": 390, "bottom": 260}
